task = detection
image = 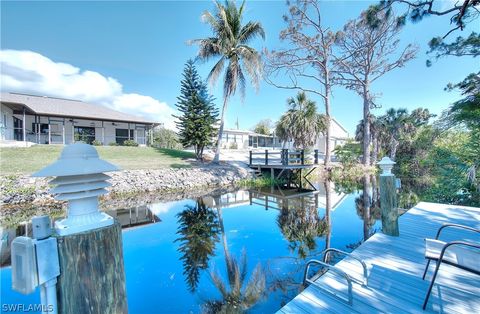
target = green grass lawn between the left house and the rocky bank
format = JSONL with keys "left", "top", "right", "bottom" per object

{"left": 0, "top": 145, "right": 194, "bottom": 175}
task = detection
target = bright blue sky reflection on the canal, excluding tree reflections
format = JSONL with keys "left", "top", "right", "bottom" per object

{"left": 0, "top": 189, "right": 382, "bottom": 313}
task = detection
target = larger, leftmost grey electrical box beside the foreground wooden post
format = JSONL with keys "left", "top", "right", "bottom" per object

{"left": 12, "top": 237, "right": 38, "bottom": 294}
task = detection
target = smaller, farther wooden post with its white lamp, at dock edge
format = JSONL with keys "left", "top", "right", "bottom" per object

{"left": 377, "top": 157, "right": 400, "bottom": 236}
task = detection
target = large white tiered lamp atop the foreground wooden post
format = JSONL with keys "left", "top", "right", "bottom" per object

{"left": 33, "top": 143, "right": 119, "bottom": 236}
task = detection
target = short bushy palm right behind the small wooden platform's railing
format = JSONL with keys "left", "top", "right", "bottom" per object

{"left": 276, "top": 92, "right": 327, "bottom": 148}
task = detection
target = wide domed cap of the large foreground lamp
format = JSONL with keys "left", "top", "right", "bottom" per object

{"left": 32, "top": 143, "right": 119, "bottom": 177}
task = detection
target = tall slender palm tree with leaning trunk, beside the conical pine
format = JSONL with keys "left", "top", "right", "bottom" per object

{"left": 191, "top": 0, "right": 265, "bottom": 163}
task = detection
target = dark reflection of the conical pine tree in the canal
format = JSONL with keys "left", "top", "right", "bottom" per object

{"left": 175, "top": 199, "right": 219, "bottom": 292}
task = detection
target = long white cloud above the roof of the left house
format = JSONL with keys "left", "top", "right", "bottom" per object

{"left": 0, "top": 50, "right": 175, "bottom": 129}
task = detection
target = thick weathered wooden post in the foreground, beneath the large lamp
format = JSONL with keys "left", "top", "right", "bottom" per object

{"left": 57, "top": 222, "right": 128, "bottom": 314}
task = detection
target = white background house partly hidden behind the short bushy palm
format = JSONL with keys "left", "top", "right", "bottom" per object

{"left": 221, "top": 118, "right": 349, "bottom": 154}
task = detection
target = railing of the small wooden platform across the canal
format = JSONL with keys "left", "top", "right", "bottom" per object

{"left": 249, "top": 149, "right": 320, "bottom": 166}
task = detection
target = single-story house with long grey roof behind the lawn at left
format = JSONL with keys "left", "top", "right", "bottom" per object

{"left": 0, "top": 93, "right": 159, "bottom": 145}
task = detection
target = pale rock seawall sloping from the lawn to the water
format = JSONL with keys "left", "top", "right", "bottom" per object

{"left": 0, "top": 165, "right": 251, "bottom": 205}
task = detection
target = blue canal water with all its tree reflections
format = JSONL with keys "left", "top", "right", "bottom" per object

{"left": 0, "top": 178, "right": 381, "bottom": 313}
